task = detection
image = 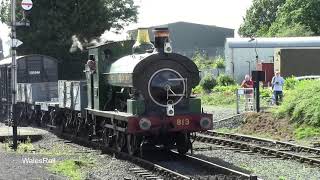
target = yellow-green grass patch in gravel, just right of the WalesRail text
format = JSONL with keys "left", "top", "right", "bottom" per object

{"left": 48, "top": 159, "right": 94, "bottom": 180}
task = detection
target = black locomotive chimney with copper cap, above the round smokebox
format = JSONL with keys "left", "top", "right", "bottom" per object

{"left": 153, "top": 28, "right": 172, "bottom": 53}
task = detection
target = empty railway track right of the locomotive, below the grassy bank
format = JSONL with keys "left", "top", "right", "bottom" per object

{"left": 195, "top": 130, "right": 320, "bottom": 166}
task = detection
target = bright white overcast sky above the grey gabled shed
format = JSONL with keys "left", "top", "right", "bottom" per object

{"left": 0, "top": 0, "right": 252, "bottom": 55}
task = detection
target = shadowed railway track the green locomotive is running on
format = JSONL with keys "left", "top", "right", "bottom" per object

{"left": 50, "top": 129, "right": 258, "bottom": 180}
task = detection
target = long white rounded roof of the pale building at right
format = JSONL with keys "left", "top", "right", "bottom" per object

{"left": 226, "top": 36, "right": 320, "bottom": 48}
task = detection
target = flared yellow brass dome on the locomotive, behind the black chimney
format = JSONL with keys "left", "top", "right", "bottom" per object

{"left": 132, "top": 28, "right": 154, "bottom": 54}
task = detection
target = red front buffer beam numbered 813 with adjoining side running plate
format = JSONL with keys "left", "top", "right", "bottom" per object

{"left": 86, "top": 109, "right": 212, "bottom": 134}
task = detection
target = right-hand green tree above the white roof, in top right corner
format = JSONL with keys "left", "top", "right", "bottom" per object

{"left": 269, "top": 0, "right": 320, "bottom": 36}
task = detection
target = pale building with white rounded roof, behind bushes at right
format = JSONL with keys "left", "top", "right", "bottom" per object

{"left": 225, "top": 37, "right": 320, "bottom": 82}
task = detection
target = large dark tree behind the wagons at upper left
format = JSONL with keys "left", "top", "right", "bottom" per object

{"left": 0, "top": 0, "right": 137, "bottom": 61}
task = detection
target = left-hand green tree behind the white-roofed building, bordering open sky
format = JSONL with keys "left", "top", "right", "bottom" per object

{"left": 238, "top": 0, "right": 286, "bottom": 37}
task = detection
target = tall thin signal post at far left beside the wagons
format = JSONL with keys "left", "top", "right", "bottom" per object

{"left": 11, "top": 0, "right": 18, "bottom": 150}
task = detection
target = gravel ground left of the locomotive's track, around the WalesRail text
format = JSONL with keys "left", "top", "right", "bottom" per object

{"left": 0, "top": 125, "right": 141, "bottom": 180}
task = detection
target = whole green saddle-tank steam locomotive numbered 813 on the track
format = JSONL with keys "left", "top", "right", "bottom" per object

{"left": 85, "top": 28, "right": 212, "bottom": 154}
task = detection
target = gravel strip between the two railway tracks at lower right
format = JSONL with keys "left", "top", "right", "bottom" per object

{"left": 194, "top": 142, "right": 320, "bottom": 180}
